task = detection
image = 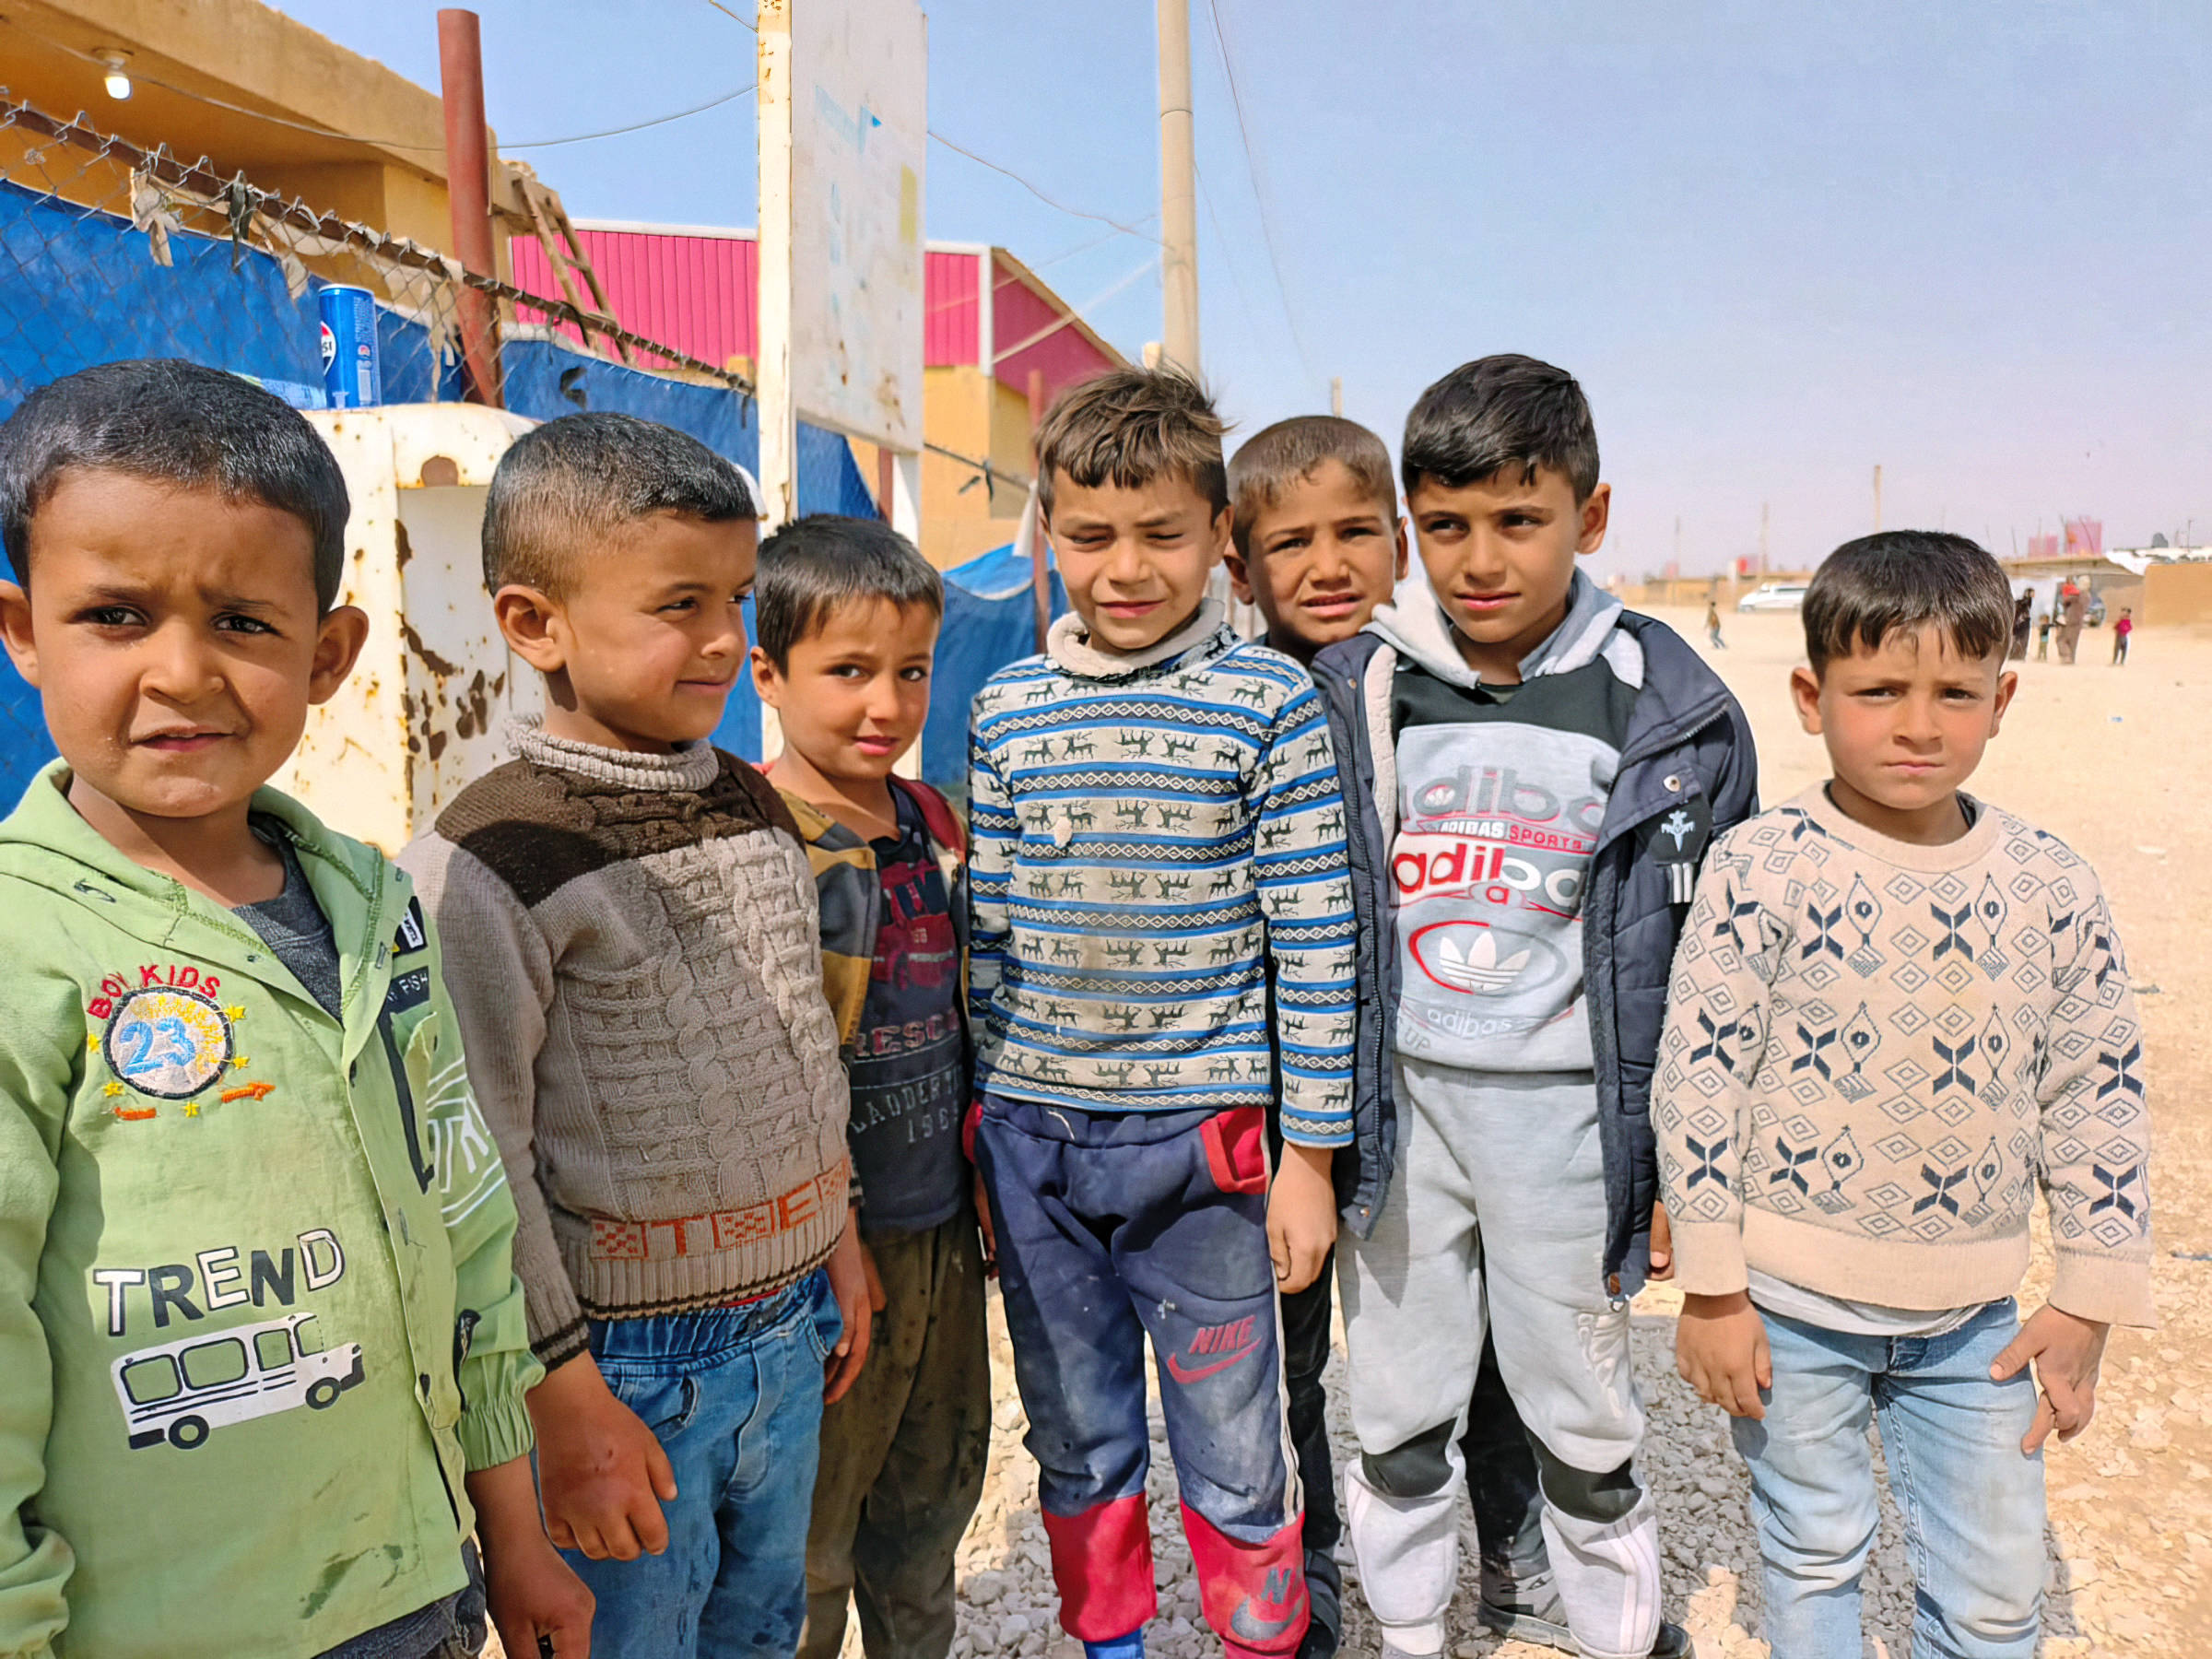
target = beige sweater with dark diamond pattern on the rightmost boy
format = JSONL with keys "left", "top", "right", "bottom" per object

{"left": 1653, "top": 785, "right": 2155, "bottom": 1325}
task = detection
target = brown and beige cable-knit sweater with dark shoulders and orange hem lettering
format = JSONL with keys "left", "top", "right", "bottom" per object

{"left": 400, "top": 725, "right": 847, "bottom": 1370}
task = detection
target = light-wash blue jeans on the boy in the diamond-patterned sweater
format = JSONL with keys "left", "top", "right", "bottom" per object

{"left": 1735, "top": 1300, "right": 2044, "bottom": 1659}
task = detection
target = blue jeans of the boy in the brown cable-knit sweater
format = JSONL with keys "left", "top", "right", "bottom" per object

{"left": 562, "top": 1270, "right": 842, "bottom": 1659}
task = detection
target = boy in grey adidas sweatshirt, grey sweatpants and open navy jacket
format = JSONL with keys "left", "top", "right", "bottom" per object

{"left": 1314, "top": 356, "right": 1754, "bottom": 1659}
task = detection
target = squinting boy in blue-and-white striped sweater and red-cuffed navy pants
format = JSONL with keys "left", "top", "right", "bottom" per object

{"left": 969, "top": 370, "right": 1354, "bottom": 1659}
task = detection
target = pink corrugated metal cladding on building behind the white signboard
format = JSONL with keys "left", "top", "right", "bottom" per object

{"left": 509, "top": 226, "right": 1112, "bottom": 398}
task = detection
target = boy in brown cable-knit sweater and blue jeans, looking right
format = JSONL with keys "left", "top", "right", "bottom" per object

{"left": 403, "top": 411, "right": 872, "bottom": 1659}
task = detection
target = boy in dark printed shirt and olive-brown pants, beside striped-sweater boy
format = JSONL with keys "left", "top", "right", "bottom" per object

{"left": 752, "top": 513, "right": 991, "bottom": 1659}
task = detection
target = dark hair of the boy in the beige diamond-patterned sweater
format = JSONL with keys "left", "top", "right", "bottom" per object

{"left": 1803, "top": 531, "right": 2013, "bottom": 675}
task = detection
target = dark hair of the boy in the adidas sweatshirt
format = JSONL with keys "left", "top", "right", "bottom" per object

{"left": 1398, "top": 354, "right": 1597, "bottom": 504}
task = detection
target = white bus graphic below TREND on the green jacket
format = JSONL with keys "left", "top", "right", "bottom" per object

{"left": 115, "top": 1314, "right": 360, "bottom": 1451}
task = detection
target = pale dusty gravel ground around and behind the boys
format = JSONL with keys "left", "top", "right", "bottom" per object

{"left": 920, "top": 613, "right": 2212, "bottom": 1659}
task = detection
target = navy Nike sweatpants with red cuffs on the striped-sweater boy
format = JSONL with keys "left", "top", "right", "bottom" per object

{"left": 975, "top": 1095, "right": 1307, "bottom": 1657}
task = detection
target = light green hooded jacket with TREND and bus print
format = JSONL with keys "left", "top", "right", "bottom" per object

{"left": 0, "top": 765, "right": 542, "bottom": 1659}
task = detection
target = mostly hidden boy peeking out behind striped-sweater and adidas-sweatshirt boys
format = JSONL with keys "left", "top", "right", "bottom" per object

{"left": 1228, "top": 416, "right": 1572, "bottom": 1659}
